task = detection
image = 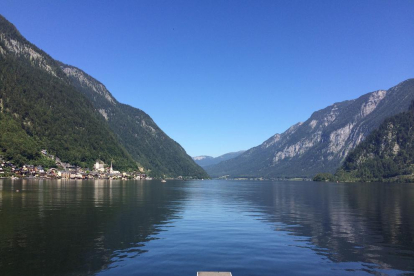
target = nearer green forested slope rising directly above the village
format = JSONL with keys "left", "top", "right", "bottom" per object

{"left": 0, "top": 16, "right": 136, "bottom": 169}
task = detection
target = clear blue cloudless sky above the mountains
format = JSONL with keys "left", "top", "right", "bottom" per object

{"left": 0, "top": 0, "right": 414, "bottom": 156}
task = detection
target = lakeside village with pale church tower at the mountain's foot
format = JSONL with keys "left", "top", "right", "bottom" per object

{"left": 0, "top": 150, "right": 158, "bottom": 180}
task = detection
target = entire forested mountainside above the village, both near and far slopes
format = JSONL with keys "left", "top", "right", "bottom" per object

{"left": 0, "top": 16, "right": 208, "bottom": 178}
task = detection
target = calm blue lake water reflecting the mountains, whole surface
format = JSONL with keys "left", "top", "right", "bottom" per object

{"left": 0, "top": 179, "right": 414, "bottom": 276}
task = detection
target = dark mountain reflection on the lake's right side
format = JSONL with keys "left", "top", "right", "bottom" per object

{"left": 238, "top": 182, "right": 414, "bottom": 272}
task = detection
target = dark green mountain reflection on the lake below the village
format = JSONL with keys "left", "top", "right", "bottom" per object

{"left": 0, "top": 180, "right": 185, "bottom": 275}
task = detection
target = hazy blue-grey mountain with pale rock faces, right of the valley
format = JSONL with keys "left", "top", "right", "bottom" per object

{"left": 206, "top": 79, "right": 414, "bottom": 178}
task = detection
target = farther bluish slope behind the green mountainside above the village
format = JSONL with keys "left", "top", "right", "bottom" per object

{"left": 60, "top": 64, "right": 208, "bottom": 178}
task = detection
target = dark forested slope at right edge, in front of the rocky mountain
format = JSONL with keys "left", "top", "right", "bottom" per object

{"left": 336, "top": 102, "right": 414, "bottom": 181}
